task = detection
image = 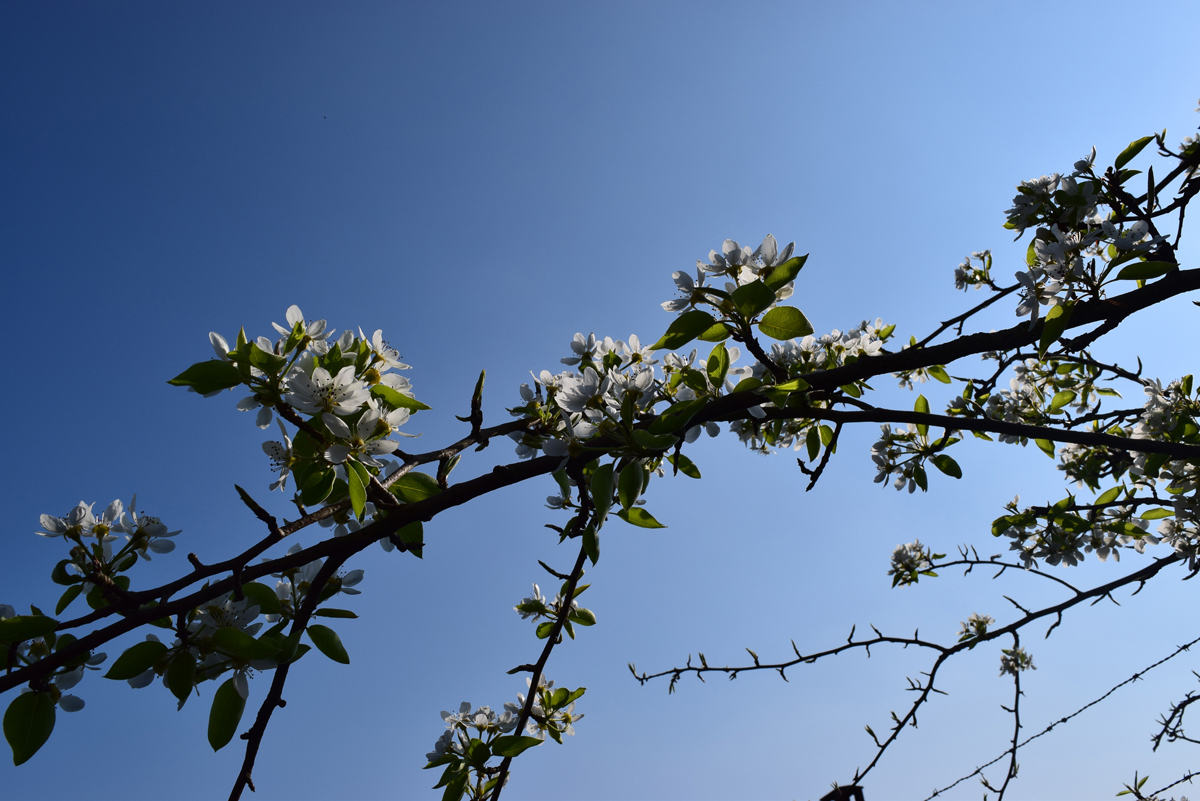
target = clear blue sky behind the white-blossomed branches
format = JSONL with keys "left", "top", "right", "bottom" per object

{"left": 0, "top": 2, "right": 1200, "bottom": 801}
